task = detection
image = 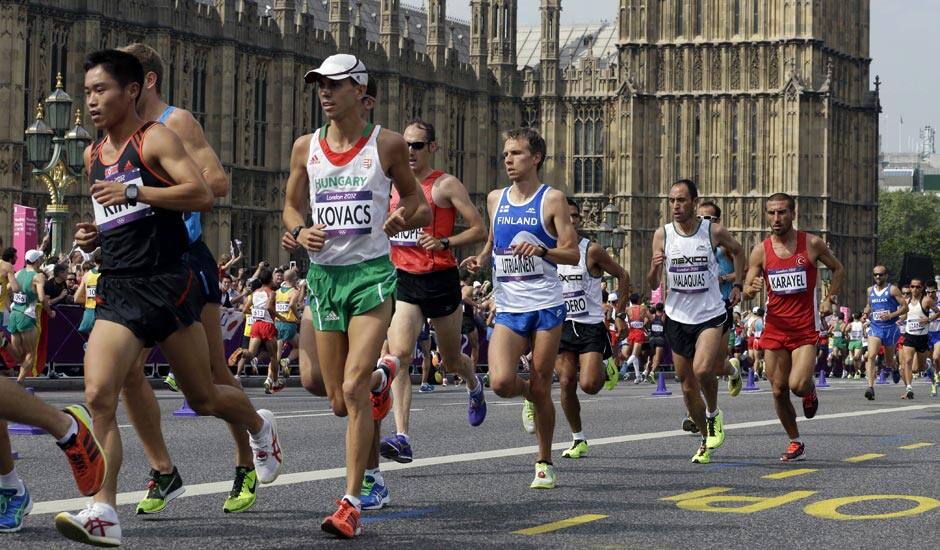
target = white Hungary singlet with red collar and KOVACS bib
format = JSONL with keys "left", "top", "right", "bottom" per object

{"left": 307, "top": 125, "right": 392, "bottom": 265}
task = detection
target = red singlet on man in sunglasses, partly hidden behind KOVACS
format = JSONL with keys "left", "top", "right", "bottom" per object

{"left": 389, "top": 170, "right": 457, "bottom": 273}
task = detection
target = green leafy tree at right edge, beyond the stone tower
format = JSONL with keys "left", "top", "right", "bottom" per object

{"left": 878, "top": 191, "right": 940, "bottom": 276}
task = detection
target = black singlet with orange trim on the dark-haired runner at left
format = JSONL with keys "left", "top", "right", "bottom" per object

{"left": 89, "top": 121, "right": 189, "bottom": 277}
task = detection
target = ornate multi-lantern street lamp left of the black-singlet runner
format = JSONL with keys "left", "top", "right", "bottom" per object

{"left": 25, "top": 74, "right": 92, "bottom": 255}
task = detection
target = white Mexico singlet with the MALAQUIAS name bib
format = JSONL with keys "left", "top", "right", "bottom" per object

{"left": 663, "top": 220, "right": 725, "bottom": 325}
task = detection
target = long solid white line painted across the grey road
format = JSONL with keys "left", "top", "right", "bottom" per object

{"left": 32, "top": 404, "right": 940, "bottom": 516}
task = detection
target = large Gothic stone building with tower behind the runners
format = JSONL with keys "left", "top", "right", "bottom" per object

{"left": 0, "top": 0, "right": 879, "bottom": 305}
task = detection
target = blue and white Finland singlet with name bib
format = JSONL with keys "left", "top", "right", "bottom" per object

{"left": 493, "top": 183, "right": 564, "bottom": 313}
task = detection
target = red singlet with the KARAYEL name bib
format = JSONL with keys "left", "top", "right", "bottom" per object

{"left": 764, "top": 231, "right": 819, "bottom": 332}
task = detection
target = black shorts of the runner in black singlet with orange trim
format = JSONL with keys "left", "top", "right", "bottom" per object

{"left": 95, "top": 265, "right": 199, "bottom": 348}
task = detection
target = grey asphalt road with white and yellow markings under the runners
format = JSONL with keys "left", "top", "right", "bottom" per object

{"left": 0, "top": 374, "right": 940, "bottom": 549}
